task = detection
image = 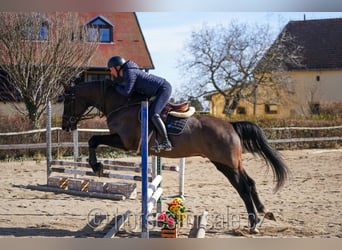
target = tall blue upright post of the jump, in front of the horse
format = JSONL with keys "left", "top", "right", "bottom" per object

{"left": 141, "top": 101, "right": 149, "bottom": 238}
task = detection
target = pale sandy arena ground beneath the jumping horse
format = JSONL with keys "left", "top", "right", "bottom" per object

{"left": 0, "top": 149, "right": 342, "bottom": 238}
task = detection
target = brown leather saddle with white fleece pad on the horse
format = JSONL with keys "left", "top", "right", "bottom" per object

{"left": 160, "top": 101, "right": 195, "bottom": 123}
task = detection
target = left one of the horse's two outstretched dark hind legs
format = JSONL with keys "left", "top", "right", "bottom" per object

{"left": 213, "top": 162, "right": 260, "bottom": 232}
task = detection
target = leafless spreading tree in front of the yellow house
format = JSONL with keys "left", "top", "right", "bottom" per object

{"left": 180, "top": 22, "right": 302, "bottom": 114}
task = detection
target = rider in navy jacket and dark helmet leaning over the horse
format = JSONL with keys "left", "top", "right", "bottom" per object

{"left": 108, "top": 56, "right": 172, "bottom": 151}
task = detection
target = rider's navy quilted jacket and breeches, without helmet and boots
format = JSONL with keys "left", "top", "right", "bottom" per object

{"left": 115, "top": 61, "right": 172, "bottom": 117}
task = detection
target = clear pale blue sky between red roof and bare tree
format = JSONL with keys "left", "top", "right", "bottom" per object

{"left": 136, "top": 11, "right": 342, "bottom": 95}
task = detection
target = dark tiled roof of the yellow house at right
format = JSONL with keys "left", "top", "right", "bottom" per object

{"left": 284, "top": 18, "right": 342, "bottom": 69}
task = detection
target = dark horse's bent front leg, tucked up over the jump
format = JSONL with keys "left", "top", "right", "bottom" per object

{"left": 88, "top": 134, "right": 125, "bottom": 177}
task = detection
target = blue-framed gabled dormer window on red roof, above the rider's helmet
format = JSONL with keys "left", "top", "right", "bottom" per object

{"left": 86, "top": 16, "right": 113, "bottom": 43}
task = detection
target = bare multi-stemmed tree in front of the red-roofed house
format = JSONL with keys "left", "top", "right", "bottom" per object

{"left": 0, "top": 12, "right": 98, "bottom": 127}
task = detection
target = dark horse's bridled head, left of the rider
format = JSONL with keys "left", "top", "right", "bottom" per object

{"left": 62, "top": 85, "right": 88, "bottom": 131}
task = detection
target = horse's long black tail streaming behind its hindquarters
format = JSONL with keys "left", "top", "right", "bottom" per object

{"left": 232, "top": 121, "right": 289, "bottom": 192}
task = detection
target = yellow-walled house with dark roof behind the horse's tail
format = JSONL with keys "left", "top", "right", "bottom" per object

{"left": 206, "top": 18, "right": 342, "bottom": 118}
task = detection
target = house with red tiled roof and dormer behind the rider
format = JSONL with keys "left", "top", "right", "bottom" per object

{"left": 0, "top": 12, "right": 154, "bottom": 116}
